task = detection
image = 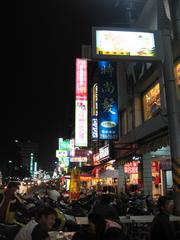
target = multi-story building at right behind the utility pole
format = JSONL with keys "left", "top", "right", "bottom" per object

{"left": 116, "top": 0, "right": 180, "bottom": 197}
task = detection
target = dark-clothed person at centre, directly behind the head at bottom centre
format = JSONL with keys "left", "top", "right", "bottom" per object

{"left": 90, "top": 194, "right": 119, "bottom": 220}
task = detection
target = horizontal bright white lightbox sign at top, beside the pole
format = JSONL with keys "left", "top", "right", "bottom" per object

{"left": 92, "top": 27, "right": 162, "bottom": 61}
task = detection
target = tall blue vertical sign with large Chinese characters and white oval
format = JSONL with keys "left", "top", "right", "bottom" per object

{"left": 98, "top": 61, "right": 118, "bottom": 140}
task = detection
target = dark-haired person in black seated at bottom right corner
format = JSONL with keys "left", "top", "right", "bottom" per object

{"left": 150, "top": 196, "right": 176, "bottom": 240}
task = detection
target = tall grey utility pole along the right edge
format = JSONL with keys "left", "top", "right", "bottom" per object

{"left": 156, "top": 0, "right": 180, "bottom": 215}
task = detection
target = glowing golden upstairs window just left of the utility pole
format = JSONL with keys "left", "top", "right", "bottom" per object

{"left": 143, "top": 83, "right": 161, "bottom": 121}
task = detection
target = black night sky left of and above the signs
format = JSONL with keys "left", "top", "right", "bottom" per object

{"left": 0, "top": 0, "right": 143, "bottom": 171}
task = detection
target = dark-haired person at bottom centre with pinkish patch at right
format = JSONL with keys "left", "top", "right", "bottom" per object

{"left": 88, "top": 213, "right": 123, "bottom": 240}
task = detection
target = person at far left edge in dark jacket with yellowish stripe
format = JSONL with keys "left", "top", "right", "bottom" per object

{"left": 0, "top": 182, "right": 23, "bottom": 223}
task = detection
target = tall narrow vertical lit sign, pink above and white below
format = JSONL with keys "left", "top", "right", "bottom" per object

{"left": 75, "top": 59, "right": 88, "bottom": 147}
